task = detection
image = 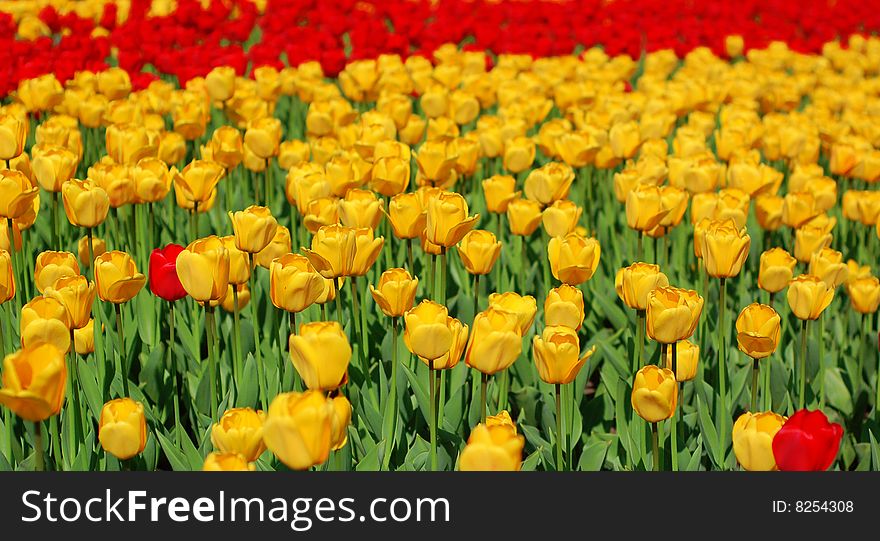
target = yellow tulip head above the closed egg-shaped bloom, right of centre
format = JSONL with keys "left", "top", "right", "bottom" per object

{"left": 646, "top": 287, "right": 703, "bottom": 344}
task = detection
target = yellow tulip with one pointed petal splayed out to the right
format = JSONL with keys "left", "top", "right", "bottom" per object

{"left": 532, "top": 325, "right": 596, "bottom": 384}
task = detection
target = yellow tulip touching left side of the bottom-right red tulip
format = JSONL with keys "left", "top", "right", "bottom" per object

{"left": 733, "top": 411, "right": 786, "bottom": 471}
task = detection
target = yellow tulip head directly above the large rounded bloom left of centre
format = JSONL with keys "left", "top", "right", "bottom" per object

{"left": 269, "top": 254, "right": 324, "bottom": 313}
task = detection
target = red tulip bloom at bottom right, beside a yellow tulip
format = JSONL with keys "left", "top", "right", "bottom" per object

{"left": 773, "top": 409, "right": 843, "bottom": 471}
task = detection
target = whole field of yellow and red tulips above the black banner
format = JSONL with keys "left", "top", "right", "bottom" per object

{"left": 0, "top": 0, "right": 880, "bottom": 471}
